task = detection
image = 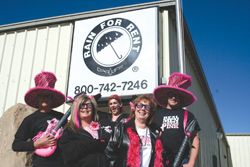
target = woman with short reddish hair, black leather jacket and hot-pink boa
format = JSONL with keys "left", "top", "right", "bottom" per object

{"left": 105, "top": 95, "right": 163, "bottom": 167}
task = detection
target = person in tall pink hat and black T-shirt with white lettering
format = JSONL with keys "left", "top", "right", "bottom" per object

{"left": 151, "top": 72, "right": 200, "bottom": 167}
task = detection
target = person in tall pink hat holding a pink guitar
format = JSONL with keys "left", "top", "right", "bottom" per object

{"left": 12, "top": 72, "right": 65, "bottom": 167}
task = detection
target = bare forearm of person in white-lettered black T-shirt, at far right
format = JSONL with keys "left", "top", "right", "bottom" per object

{"left": 183, "top": 133, "right": 200, "bottom": 167}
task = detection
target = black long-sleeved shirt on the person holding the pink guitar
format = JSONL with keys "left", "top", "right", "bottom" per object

{"left": 12, "top": 110, "right": 63, "bottom": 167}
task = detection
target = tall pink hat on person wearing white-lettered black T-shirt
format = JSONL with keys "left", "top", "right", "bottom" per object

{"left": 154, "top": 72, "right": 197, "bottom": 107}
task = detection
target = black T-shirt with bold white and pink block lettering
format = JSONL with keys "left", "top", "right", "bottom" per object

{"left": 153, "top": 108, "right": 200, "bottom": 157}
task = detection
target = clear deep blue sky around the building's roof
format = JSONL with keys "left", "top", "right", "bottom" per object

{"left": 0, "top": 0, "right": 250, "bottom": 133}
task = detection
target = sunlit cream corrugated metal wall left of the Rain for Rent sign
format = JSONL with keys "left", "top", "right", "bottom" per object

{"left": 0, "top": 23, "right": 73, "bottom": 116}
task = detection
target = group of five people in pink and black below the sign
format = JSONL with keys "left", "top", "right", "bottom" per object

{"left": 12, "top": 72, "right": 200, "bottom": 167}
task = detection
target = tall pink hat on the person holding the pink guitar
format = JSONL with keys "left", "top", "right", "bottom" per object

{"left": 24, "top": 71, "right": 66, "bottom": 108}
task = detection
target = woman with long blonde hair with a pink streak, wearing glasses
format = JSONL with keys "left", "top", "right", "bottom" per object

{"left": 59, "top": 94, "right": 111, "bottom": 167}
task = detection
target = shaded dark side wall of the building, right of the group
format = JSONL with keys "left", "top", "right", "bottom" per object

{"left": 182, "top": 41, "right": 232, "bottom": 167}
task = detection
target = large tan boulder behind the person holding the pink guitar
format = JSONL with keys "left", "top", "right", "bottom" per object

{"left": 0, "top": 104, "right": 34, "bottom": 167}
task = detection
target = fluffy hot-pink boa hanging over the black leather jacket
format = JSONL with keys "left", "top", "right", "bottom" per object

{"left": 127, "top": 128, "right": 163, "bottom": 167}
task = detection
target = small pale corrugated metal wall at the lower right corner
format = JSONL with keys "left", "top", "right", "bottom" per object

{"left": 227, "top": 134, "right": 250, "bottom": 167}
